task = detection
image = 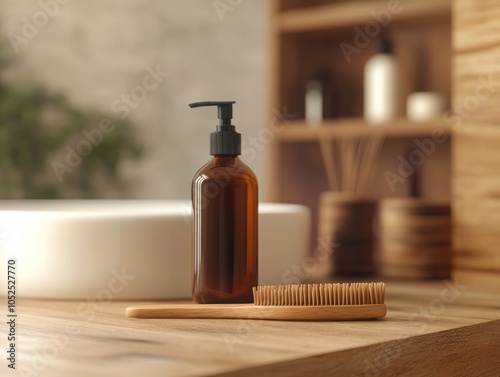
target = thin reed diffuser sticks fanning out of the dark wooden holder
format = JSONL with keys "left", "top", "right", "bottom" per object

{"left": 319, "top": 137, "right": 384, "bottom": 194}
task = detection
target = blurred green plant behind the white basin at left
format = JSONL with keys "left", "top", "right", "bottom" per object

{"left": 0, "top": 50, "right": 141, "bottom": 199}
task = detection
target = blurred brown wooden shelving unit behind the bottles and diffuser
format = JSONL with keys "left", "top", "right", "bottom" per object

{"left": 267, "top": 0, "right": 452, "bottom": 251}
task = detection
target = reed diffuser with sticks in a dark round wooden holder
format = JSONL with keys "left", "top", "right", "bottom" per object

{"left": 318, "top": 137, "right": 383, "bottom": 276}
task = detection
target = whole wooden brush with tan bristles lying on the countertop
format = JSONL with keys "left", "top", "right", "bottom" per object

{"left": 125, "top": 283, "right": 386, "bottom": 321}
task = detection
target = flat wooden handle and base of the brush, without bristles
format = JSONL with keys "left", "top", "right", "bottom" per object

{"left": 126, "top": 304, "right": 386, "bottom": 321}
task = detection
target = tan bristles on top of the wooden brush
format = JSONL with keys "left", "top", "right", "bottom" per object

{"left": 253, "top": 283, "right": 385, "bottom": 306}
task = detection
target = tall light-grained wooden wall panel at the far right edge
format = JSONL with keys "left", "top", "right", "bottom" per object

{"left": 452, "top": 0, "right": 500, "bottom": 287}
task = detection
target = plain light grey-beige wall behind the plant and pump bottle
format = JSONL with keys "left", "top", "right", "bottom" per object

{"left": 0, "top": 0, "right": 267, "bottom": 199}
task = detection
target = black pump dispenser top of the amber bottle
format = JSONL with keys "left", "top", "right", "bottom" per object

{"left": 189, "top": 101, "right": 241, "bottom": 156}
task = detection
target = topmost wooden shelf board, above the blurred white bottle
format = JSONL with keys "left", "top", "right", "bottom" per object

{"left": 277, "top": 0, "right": 451, "bottom": 33}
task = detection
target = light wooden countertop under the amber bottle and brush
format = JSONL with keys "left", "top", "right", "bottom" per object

{"left": 7, "top": 281, "right": 500, "bottom": 377}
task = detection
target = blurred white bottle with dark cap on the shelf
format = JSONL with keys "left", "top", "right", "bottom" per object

{"left": 364, "top": 38, "right": 399, "bottom": 124}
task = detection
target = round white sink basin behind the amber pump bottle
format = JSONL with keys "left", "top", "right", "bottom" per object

{"left": 0, "top": 200, "right": 310, "bottom": 301}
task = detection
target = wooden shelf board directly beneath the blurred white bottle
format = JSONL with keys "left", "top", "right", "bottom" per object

{"left": 276, "top": 118, "right": 451, "bottom": 142}
